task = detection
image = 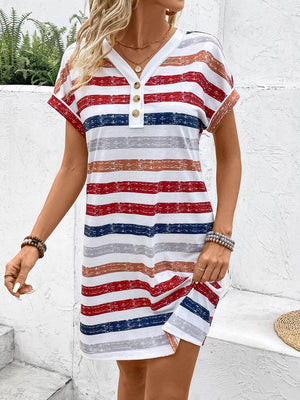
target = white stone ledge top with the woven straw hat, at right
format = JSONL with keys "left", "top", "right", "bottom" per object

{"left": 208, "top": 287, "right": 300, "bottom": 358}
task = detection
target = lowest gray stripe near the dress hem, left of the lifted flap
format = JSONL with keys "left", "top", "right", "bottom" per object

{"left": 79, "top": 333, "right": 169, "bottom": 354}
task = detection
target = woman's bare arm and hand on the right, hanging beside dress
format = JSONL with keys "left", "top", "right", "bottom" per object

{"left": 193, "top": 109, "right": 242, "bottom": 282}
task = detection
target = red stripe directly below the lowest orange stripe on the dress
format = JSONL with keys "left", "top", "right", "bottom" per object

{"left": 81, "top": 275, "right": 188, "bottom": 297}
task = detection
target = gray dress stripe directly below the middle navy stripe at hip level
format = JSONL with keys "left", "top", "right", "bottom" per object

{"left": 83, "top": 242, "right": 203, "bottom": 257}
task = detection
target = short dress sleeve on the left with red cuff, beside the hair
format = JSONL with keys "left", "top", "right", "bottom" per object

{"left": 47, "top": 43, "right": 85, "bottom": 137}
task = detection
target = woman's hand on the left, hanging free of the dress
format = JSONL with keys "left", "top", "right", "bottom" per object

{"left": 4, "top": 246, "right": 39, "bottom": 299}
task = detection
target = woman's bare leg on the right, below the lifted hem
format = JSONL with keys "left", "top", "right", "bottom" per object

{"left": 144, "top": 339, "right": 200, "bottom": 400}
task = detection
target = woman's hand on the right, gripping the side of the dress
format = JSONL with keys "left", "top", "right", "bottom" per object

{"left": 193, "top": 242, "right": 231, "bottom": 282}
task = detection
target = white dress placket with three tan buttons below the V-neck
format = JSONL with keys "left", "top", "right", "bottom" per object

{"left": 129, "top": 80, "right": 144, "bottom": 128}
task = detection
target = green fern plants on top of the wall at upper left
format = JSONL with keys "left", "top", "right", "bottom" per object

{"left": 0, "top": 7, "right": 86, "bottom": 86}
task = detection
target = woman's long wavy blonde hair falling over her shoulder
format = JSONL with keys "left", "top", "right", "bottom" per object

{"left": 67, "top": 0, "right": 178, "bottom": 95}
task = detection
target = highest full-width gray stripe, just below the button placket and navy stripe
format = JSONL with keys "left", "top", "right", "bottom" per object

{"left": 88, "top": 136, "right": 199, "bottom": 151}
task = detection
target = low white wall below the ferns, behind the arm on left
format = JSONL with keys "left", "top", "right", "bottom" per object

{"left": 0, "top": 85, "right": 75, "bottom": 373}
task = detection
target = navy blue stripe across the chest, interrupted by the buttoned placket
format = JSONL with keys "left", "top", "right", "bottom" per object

{"left": 83, "top": 112, "right": 207, "bottom": 132}
